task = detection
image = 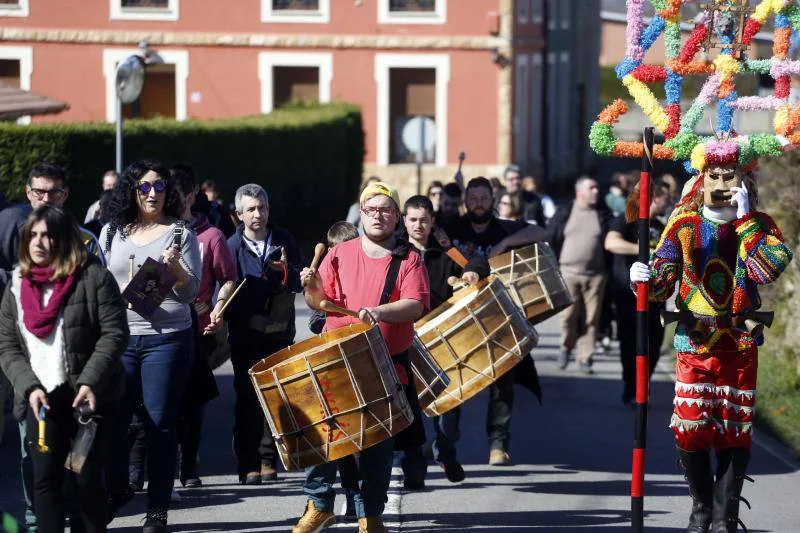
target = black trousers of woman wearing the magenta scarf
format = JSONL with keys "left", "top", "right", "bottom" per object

{"left": 27, "top": 385, "right": 110, "bottom": 533}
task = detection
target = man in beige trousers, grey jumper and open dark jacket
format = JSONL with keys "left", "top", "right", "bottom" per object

{"left": 547, "top": 176, "right": 612, "bottom": 374}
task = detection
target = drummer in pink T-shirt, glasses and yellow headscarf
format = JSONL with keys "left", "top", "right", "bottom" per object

{"left": 292, "top": 182, "right": 430, "bottom": 533}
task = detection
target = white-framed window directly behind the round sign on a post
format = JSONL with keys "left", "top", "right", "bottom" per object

{"left": 374, "top": 54, "right": 450, "bottom": 166}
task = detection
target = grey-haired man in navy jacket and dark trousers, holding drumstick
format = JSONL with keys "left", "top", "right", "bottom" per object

{"left": 226, "top": 183, "right": 302, "bottom": 485}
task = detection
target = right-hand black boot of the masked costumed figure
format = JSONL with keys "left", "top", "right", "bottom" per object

{"left": 712, "top": 448, "right": 750, "bottom": 533}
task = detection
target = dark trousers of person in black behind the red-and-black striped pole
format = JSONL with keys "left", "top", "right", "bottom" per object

{"left": 614, "top": 290, "right": 664, "bottom": 402}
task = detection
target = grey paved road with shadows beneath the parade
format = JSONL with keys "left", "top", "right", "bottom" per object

{"left": 0, "top": 298, "right": 800, "bottom": 533}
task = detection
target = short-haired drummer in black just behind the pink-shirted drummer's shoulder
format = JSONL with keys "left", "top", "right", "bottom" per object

{"left": 401, "top": 195, "right": 489, "bottom": 490}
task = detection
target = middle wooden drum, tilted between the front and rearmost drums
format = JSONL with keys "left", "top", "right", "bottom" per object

{"left": 414, "top": 276, "right": 539, "bottom": 416}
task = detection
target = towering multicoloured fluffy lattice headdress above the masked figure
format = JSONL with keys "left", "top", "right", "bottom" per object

{"left": 589, "top": 0, "right": 800, "bottom": 172}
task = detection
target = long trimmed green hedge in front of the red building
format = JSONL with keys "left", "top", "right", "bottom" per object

{"left": 0, "top": 104, "right": 364, "bottom": 255}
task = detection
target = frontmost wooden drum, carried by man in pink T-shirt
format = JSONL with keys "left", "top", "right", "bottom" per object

{"left": 250, "top": 324, "right": 414, "bottom": 470}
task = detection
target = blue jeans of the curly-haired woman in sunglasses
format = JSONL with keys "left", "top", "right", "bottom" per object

{"left": 108, "top": 328, "right": 194, "bottom": 510}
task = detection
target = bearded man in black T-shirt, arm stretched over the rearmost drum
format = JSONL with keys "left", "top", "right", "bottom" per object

{"left": 450, "top": 177, "right": 546, "bottom": 466}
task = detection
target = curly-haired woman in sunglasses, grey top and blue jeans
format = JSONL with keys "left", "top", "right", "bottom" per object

{"left": 100, "top": 160, "right": 202, "bottom": 533}
